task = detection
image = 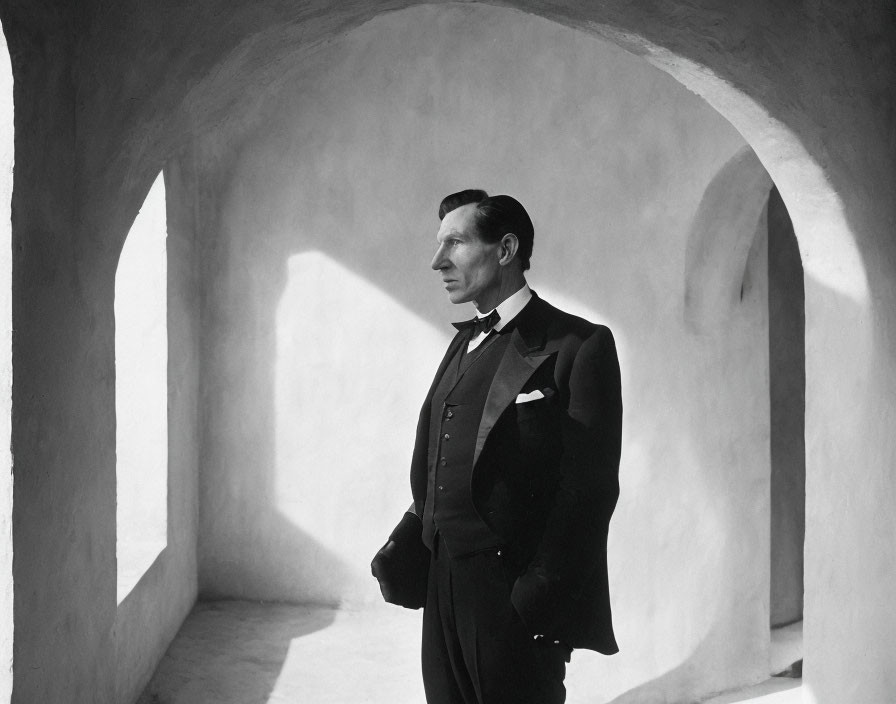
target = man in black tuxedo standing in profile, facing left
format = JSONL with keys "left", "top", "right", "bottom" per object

{"left": 372, "top": 190, "right": 622, "bottom": 704}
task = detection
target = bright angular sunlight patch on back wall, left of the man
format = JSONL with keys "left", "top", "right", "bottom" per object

{"left": 274, "top": 251, "right": 442, "bottom": 601}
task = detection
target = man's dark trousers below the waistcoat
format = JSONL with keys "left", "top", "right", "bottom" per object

{"left": 422, "top": 535, "right": 570, "bottom": 704}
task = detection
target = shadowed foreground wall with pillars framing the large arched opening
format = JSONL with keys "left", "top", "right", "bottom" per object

{"left": 0, "top": 0, "right": 896, "bottom": 704}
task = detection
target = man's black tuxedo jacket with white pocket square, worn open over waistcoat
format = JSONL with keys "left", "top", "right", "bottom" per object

{"left": 374, "top": 293, "right": 622, "bottom": 654}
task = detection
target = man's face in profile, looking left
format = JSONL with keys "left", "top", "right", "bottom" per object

{"left": 432, "top": 204, "right": 501, "bottom": 307}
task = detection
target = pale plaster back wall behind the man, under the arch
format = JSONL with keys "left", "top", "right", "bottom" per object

{"left": 199, "top": 7, "right": 769, "bottom": 702}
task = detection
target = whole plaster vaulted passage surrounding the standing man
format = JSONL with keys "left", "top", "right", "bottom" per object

{"left": 0, "top": 0, "right": 896, "bottom": 704}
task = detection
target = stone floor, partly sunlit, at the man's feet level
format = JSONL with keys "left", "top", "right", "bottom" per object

{"left": 138, "top": 601, "right": 800, "bottom": 704}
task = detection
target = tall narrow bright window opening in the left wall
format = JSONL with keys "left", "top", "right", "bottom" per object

{"left": 115, "top": 174, "right": 168, "bottom": 604}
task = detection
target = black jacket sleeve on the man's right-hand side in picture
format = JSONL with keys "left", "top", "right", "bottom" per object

{"left": 511, "top": 326, "right": 622, "bottom": 637}
